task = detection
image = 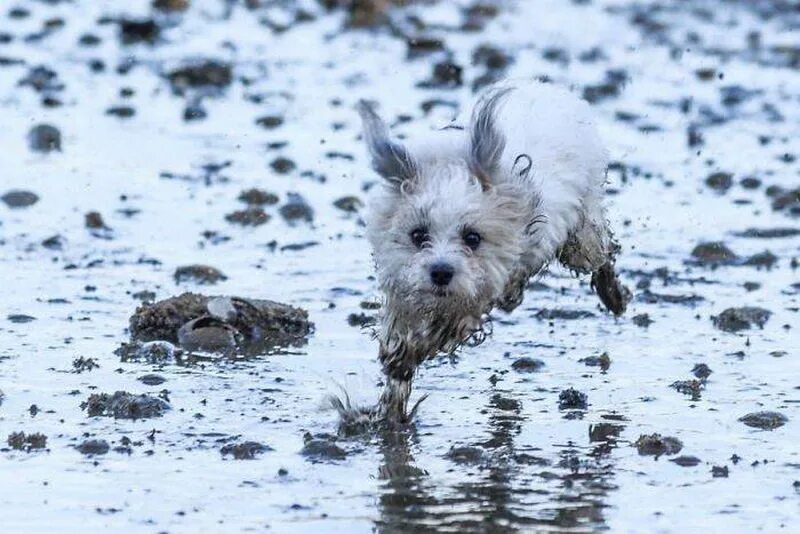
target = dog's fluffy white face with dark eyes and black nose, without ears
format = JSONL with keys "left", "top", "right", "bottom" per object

{"left": 367, "top": 170, "right": 529, "bottom": 316}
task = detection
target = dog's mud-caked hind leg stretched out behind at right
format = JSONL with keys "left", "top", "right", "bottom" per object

{"left": 558, "top": 207, "right": 631, "bottom": 315}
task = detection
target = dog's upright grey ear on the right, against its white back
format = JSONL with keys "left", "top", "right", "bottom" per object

{"left": 468, "top": 88, "right": 511, "bottom": 190}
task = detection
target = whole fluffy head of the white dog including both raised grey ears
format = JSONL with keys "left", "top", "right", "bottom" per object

{"left": 359, "top": 92, "right": 531, "bottom": 316}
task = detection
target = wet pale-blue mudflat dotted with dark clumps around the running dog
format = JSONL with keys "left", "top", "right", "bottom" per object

{"left": 0, "top": 0, "right": 800, "bottom": 532}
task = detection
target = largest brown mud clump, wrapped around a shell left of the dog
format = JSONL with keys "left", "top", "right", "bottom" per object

{"left": 130, "top": 293, "right": 313, "bottom": 350}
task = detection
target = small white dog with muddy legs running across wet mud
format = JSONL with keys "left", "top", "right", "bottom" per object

{"left": 359, "top": 82, "right": 630, "bottom": 421}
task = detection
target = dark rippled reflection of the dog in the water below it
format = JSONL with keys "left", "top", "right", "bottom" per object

{"left": 375, "top": 392, "right": 624, "bottom": 532}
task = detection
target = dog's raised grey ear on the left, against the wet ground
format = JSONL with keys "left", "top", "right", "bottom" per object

{"left": 357, "top": 100, "right": 416, "bottom": 187}
